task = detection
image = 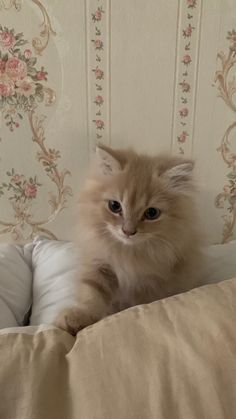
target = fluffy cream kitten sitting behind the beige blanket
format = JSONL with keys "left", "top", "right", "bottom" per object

{"left": 56, "top": 145, "right": 205, "bottom": 334}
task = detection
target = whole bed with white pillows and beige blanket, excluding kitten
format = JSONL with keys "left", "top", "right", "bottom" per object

{"left": 0, "top": 237, "right": 236, "bottom": 419}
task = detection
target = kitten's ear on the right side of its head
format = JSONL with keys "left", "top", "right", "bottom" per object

{"left": 162, "top": 157, "right": 194, "bottom": 192}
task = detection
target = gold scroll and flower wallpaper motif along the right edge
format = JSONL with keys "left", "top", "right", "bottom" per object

{"left": 215, "top": 29, "right": 236, "bottom": 243}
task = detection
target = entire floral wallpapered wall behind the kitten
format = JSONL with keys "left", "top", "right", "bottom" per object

{"left": 0, "top": 0, "right": 236, "bottom": 243}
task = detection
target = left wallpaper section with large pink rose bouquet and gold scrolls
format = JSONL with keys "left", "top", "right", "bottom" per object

{"left": 0, "top": 1, "right": 89, "bottom": 241}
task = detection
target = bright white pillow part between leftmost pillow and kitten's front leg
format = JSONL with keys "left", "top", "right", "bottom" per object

{"left": 30, "top": 238, "right": 78, "bottom": 326}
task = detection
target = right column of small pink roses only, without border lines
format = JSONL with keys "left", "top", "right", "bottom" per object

{"left": 176, "top": 0, "right": 197, "bottom": 154}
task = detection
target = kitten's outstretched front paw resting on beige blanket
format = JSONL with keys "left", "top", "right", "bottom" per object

{"left": 55, "top": 307, "right": 97, "bottom": 336}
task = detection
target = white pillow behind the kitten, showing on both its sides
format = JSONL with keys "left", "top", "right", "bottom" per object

{"left": 30, "top": 238, "right": 236, "bottom": 326}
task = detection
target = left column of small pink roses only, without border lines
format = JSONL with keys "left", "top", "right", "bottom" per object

{"left": 91, "top": 0, "right": 105, "bottom": 140}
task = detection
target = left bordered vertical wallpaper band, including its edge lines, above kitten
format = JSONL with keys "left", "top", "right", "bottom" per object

{"left": 85, "top": 0, "right": 109, "bottom": 149}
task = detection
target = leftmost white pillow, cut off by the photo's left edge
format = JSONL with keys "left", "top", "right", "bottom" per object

{"left": 0, "top": 243, "right": 32, "bottom": 329}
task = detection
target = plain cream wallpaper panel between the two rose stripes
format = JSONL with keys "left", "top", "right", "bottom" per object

{"left": 111, "top": 0, "right": 178, "bottom": 152}
